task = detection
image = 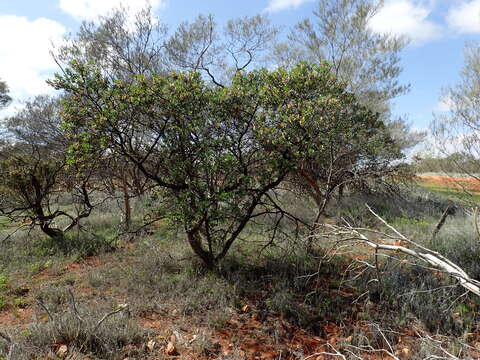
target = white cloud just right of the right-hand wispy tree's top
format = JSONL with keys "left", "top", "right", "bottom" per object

{"left": 369, "top": 0, "right": 443, "bottom": 45}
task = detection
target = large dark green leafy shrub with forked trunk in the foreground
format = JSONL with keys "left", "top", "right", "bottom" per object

{"left": 51, "top": 62, "right": 398, "bottom": 267}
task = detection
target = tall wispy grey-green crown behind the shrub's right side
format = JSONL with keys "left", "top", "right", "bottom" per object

{"left": 276, "top": 0, "right": 409, "bottom": 115}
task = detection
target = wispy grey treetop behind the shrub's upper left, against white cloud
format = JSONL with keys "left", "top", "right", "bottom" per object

{"left": 53, "top": 7, "right": 171, "bottom": 79}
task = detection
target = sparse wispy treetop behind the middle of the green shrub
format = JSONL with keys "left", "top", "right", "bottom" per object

{"left": 166, "top": 15, "right": 279, "bottom": 86}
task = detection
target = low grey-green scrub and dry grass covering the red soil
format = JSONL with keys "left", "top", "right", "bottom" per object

{"left": 0, "top": 188, "right": 480, "bottom": 359}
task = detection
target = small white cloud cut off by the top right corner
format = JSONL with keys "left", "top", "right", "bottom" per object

{"left": 447, "top": 0, "right": 480, "bottom": 33}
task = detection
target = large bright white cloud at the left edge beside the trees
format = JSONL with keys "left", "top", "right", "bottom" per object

{"left": 0, "top": 15, "right": 66, "bottom": 100}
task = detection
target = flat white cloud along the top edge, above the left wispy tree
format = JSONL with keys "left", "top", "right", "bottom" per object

{"left": 60, "top": 0, "right": 165, "bottom": 20}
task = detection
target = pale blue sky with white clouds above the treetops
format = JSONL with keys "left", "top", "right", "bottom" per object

{"left": 0, "top": 0, "right": 480, "bottom": 129}
